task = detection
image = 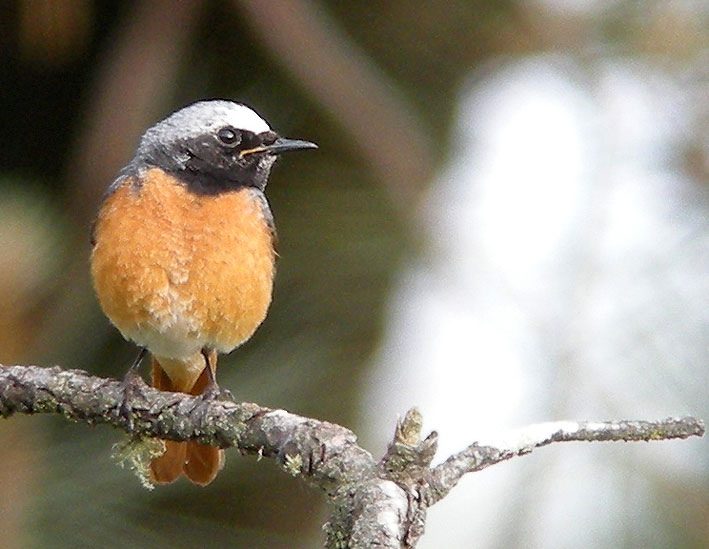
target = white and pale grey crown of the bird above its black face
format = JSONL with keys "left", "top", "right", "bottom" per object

{"left": 139, "top": 100, "right": 271, "bottom": 149}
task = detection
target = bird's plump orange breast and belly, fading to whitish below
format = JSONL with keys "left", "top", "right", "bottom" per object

{"left": 91, "top": 168, "right": 275, "bottom": 359}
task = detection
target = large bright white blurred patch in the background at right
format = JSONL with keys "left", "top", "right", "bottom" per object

{"left": 361, "top": 55, "right": 709, "bottom": 548}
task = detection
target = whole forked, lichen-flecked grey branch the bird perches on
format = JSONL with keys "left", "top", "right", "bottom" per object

{"left": 0, "top": 366, "right": 704, "bottom": 548}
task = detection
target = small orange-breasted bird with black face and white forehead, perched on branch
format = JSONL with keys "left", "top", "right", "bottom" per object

{"left": 90, "top": 99, "right": 317, "bottom": 486}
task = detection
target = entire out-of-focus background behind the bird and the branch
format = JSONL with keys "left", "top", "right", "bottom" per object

{"left": 0, "top": 0, "right": 709, "bottom": 549}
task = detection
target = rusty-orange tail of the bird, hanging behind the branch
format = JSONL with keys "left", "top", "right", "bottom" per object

{"left": 150, "top": 352, "right": 224, "bottom": 486}
